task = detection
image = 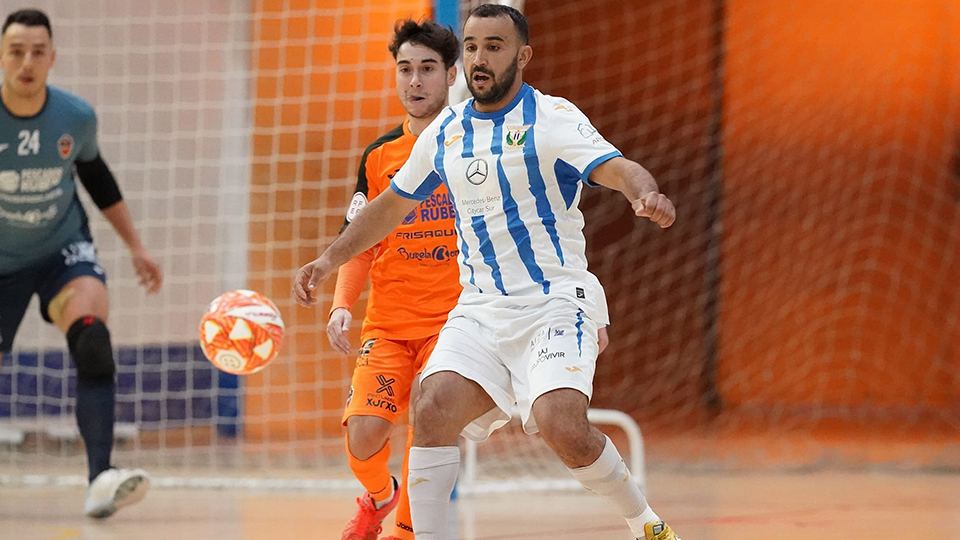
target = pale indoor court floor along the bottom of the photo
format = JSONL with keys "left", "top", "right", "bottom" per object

{"left": 0, "top": 472, "right": 960, "bottom": 540}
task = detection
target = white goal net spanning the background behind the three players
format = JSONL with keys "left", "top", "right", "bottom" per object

{"left": 0, "top": 0, "right": 960, "bottom": 489}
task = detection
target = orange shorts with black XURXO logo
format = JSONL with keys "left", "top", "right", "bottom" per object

{"left": 343, "top": 334, "right": 437, "bottom": 425}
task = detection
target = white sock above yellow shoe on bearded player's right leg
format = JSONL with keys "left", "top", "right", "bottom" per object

{"left": 570, "top": 437, "right": 660, "bottom": 538}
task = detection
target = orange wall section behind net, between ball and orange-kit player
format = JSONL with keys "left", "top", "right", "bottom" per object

{"left": 244, "top": 0, "right": 430, "bottom": 442}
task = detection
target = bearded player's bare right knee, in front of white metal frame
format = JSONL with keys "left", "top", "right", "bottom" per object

{"left": 533, "top": 389, "right": 606, "bottom": 468}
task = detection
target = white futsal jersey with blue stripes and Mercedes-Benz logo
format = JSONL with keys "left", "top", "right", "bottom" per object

{"left": 391, "top": 84, "right": 622, "bottom": 325}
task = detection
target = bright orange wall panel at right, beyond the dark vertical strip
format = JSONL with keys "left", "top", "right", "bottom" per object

{"left": 719, "top": 0, "right": 960, "bottom": 418}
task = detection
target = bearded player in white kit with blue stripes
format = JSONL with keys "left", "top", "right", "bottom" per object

{"left": 293, "top": 4, "right": 679, "bottom": 540}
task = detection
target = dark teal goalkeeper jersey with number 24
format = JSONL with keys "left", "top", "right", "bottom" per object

{"left": 0, "top": 86, "right": 100, "bottom": 275}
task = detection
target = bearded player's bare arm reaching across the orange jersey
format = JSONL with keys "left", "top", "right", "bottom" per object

{"left": 293, "top": 189, "right": 420, "bottom": 307}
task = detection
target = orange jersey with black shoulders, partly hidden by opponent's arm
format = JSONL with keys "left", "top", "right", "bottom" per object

{"left": 330, "top": 120, "right": 462, "bottom": 340}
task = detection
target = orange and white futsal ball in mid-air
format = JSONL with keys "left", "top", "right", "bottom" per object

{"left": 200, "top": 289, "right": 283, "bottom": 375}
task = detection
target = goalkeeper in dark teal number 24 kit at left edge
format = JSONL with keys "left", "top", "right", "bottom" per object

{"left": 0, "top": 9, "right": 163, "bottom": 518}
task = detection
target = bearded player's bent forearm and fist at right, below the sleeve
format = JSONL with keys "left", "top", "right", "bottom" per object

{"left": 590, "top": 157, "right": 677, "bottom": 229}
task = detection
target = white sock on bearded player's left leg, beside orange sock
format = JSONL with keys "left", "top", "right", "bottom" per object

{"left": 407, "top": 446, "right": 460, "bottom": 540}
